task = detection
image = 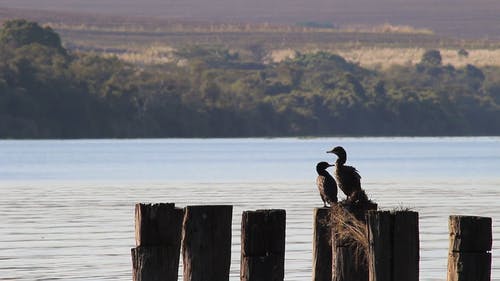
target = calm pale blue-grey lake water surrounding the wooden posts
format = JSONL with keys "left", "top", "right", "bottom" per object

{"left": 0, "top": 137, "right": 500, "bottom": 281}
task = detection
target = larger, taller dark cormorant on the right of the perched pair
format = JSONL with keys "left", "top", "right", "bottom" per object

{"left": 327, "top": 146, "right": 368, "bottom": 202}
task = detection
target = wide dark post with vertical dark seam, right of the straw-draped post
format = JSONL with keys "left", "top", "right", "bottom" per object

{"left": 367, "top": 211, "right": 420, "bottom": 281}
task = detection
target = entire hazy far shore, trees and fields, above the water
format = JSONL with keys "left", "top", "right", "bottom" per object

{"left": 0, "top": 0, "right": 500, "bottom": 138}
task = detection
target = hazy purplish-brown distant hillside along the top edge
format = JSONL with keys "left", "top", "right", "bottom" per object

{"left": 0, "top": 0, "right": 500, "bottom": 39}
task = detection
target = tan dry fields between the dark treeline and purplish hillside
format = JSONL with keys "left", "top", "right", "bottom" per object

{"left": 0, "top": 8, "right": 500, "bottom": 68}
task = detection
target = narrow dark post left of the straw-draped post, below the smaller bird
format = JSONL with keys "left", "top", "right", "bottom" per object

{"left": 312, "top": 208, "right": 332, "bottom": 281}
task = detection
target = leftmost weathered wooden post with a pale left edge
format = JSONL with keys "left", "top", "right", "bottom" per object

{"left": 132, "top": 203, "right": 184, "bottom": 281}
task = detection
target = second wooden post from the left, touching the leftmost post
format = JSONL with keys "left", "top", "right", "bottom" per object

{"left": 182, "top": 205, "right": 233, "bottom": 281}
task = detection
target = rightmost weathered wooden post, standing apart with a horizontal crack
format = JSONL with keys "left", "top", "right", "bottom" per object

{"left": 447, "top": 216, "right": 492, "bottom": 281}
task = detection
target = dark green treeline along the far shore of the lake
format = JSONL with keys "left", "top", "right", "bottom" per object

{"left": 0, "top": 20, "right": 500, "bottom": 138}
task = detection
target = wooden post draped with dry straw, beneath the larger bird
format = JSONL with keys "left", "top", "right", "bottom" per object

{"left": 331, "top": 202, "right": 377, "bottom": 281}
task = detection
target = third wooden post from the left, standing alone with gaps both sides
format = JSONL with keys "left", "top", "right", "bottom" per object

{"left": 240, "top": 210, "right": 286, "bottom": 281}
